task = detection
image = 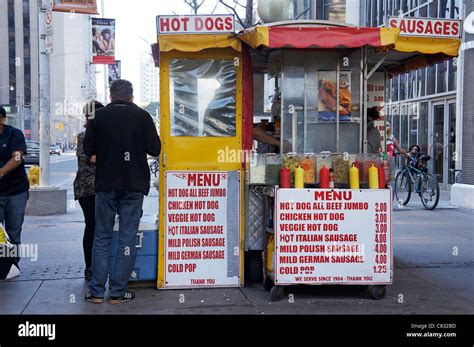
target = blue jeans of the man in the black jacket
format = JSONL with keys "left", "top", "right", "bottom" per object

{"left": 89, "top": 190, "right": 144, "bottom": 297}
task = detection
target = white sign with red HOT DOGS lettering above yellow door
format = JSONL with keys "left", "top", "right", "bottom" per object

{"left": 157, "top": 15, "right": 235, "bottom": 35}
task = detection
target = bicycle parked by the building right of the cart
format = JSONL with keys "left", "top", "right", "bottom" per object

{"left": 395, "top": 154, "right": 440, "bottom": 211}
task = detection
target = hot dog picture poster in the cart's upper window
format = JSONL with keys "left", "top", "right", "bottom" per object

{"left": 318, "top": 70, "right": 352, "bottom": 122}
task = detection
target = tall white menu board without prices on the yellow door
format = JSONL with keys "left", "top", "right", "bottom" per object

{"left": 164, "top": 171, "right": 240, "bottom": 288}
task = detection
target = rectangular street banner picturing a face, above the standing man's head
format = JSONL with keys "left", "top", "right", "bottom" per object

{"left": 92, "top": 18, "right": 115, "bottom": 65}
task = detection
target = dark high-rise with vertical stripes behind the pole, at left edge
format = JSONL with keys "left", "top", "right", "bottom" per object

{"left": 0, "top": 0, "right": 39, "bottom": 141}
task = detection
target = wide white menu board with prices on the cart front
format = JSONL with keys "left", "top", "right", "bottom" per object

{"left": 274, "top": 189, "right": 393, "bottom": 285}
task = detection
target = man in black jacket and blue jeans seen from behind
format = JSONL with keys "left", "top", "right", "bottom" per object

{"left": 84, "top": 80, "right": 161, "bottom": 304}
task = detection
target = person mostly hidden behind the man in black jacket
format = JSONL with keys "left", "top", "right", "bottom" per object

{"left": 74, "top": 101, "right": 104, "bottom": 281}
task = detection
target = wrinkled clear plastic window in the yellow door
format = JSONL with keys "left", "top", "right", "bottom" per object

{"left": 170, "top": 59, "right": 236, "bottom": 137}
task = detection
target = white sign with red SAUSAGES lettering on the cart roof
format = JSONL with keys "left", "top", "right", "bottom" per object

{"left": 388, "top": 17, "right": 461, "bottom": 38}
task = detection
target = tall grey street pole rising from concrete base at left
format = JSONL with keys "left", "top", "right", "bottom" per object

{"left": 38, "top": 0, "right": 51, "bottom": 187}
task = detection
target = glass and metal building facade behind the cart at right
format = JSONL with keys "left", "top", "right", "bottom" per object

{"left": 294, "top": 0, "right": 462, "bottom": 188}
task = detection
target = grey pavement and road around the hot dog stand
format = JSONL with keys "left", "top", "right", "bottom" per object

{"left": 0, "top": 160, "right": 474, "bottom": 315}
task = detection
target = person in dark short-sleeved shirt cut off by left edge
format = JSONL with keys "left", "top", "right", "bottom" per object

{"left": 0, "top": 107, "right": 30, "bottom": 274}
